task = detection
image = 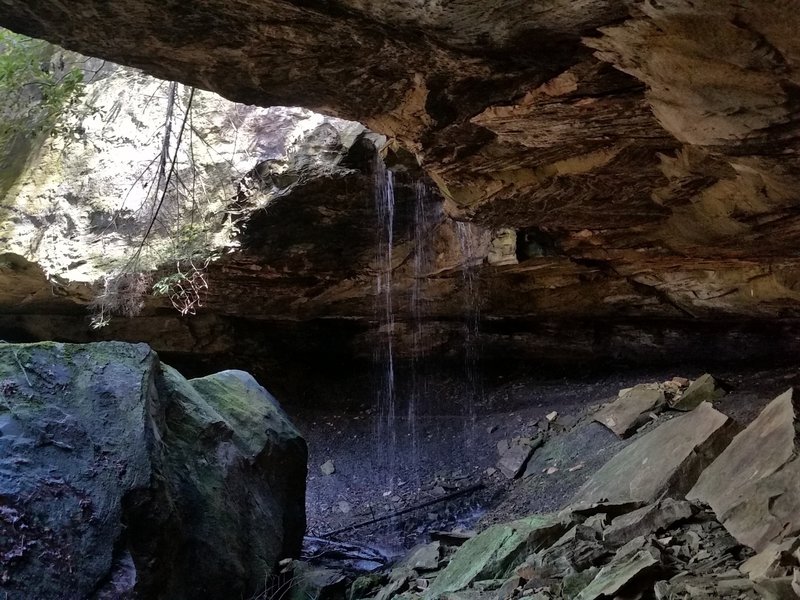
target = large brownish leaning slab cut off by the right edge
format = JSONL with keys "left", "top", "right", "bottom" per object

{"left": 687, "top": 389, "right": 800, "bottom": 552}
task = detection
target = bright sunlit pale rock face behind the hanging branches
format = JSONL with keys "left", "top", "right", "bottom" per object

{"left": 0, "top": 60, "right": 364, "bottom": 283}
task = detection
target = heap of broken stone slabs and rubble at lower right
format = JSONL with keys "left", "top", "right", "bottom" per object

{"left": 338, "top": 376, "right": 800, "bottom": 600}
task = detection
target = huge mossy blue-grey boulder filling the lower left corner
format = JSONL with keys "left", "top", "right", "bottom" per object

{"left": 0, "top": 342, "right": 306, "bottom": 600}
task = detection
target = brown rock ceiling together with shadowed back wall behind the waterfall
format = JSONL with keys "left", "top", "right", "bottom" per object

{"left": 0, "top": 0, "right": 800, "bottom": 390}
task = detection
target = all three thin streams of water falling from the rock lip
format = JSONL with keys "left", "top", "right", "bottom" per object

{"left": 373, "top": 158, "right": 483, "bottom": 491}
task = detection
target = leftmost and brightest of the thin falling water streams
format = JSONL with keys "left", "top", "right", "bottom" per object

{"left": 375, "top": 156, "right": 397, "bottom": 487}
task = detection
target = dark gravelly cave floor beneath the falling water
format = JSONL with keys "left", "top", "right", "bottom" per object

{"left": 289, "top": 366, "right": 800, "bottom": 557}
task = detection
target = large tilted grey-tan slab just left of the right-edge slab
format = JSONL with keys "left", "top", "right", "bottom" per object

{"left": 573, "top": 402, "right": 736, "bottom": 505}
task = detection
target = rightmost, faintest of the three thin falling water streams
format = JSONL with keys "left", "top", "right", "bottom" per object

{"left": 456, "top": 221, "right": 483, "bottom": 441}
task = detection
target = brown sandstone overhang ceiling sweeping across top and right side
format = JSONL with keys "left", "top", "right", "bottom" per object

{"left": 0, "top": 0, "right": 800, "bottom": 376}
